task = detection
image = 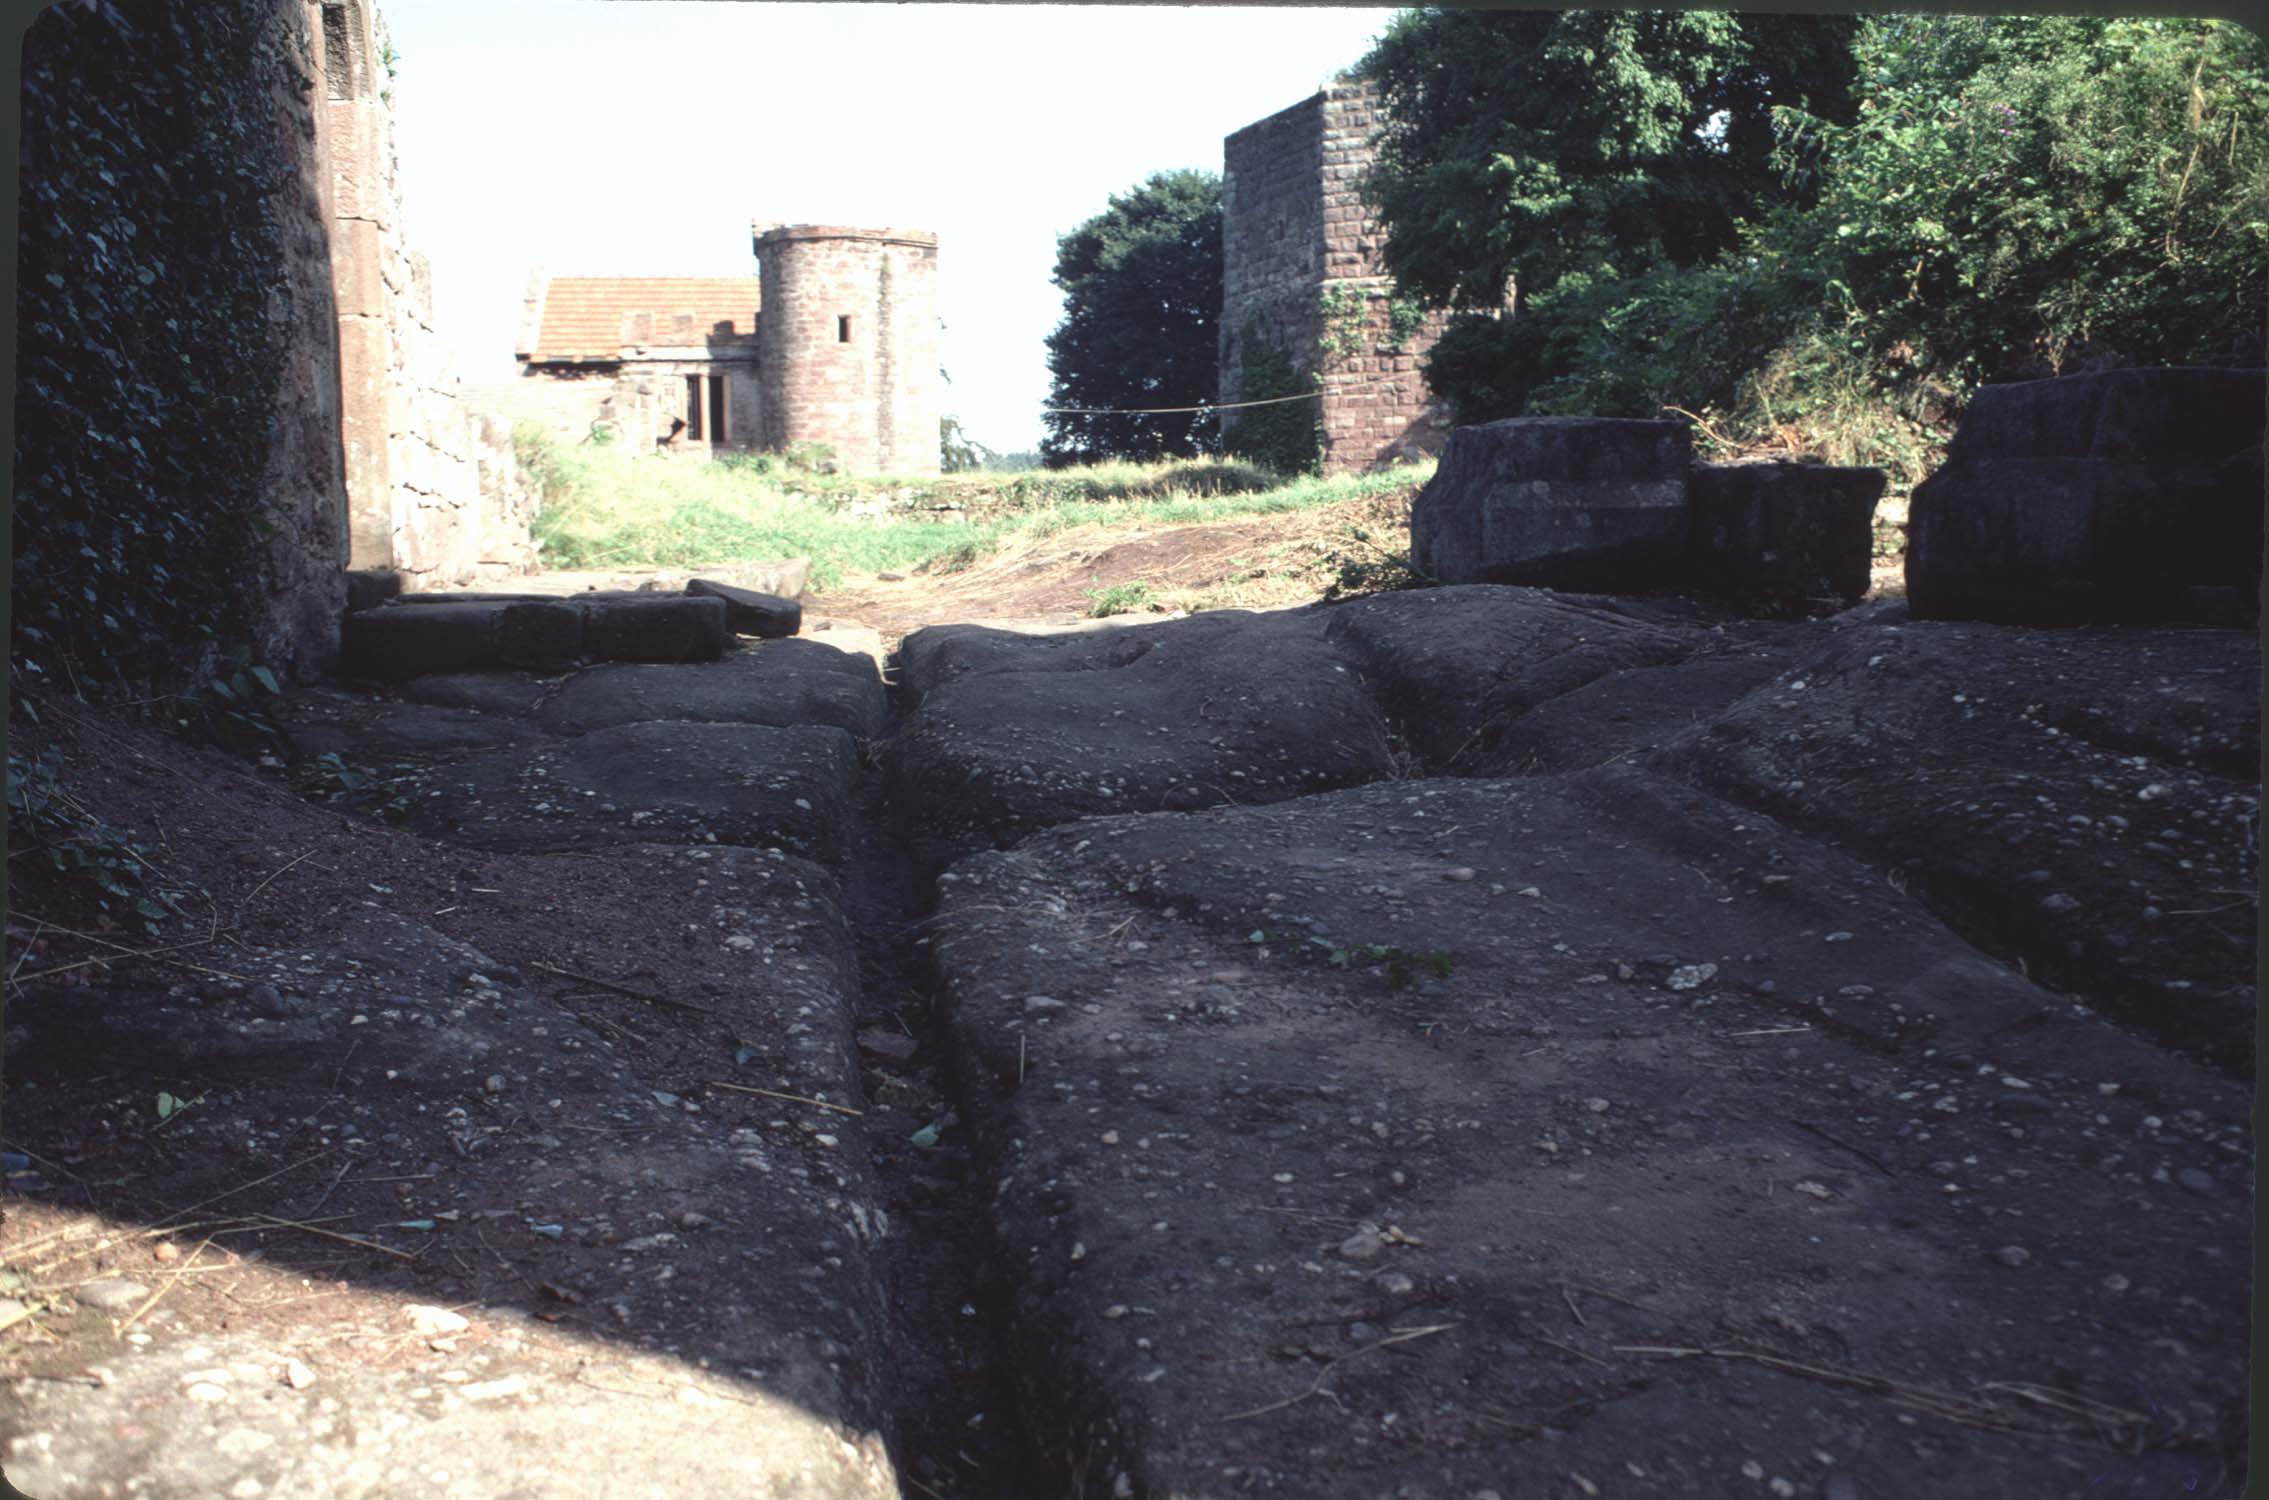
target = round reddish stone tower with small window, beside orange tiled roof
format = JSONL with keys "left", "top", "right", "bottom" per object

{"left": 753, "top": 222, "right": 942, "bottom": 474}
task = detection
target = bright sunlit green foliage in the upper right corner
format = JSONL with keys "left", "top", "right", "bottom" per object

{"left": 1788, "top": 16, "right": 2269, "bottom": 386}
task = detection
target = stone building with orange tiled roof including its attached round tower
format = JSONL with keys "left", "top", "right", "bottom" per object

{"left": 496, "top": 222, "right": 942, "bottom": 474}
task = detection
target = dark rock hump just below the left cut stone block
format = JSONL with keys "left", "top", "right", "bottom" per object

{"left": 1325, "top": 583, "right": 1720, "bottom": 774}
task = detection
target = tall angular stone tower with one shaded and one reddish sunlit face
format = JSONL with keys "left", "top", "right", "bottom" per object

{"left": 1221, "top": 79, "right": 1450, "bottom": 474}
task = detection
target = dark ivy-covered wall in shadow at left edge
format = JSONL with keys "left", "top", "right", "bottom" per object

{"left": 11, "top": 0, "right": 347, "bottom": 692}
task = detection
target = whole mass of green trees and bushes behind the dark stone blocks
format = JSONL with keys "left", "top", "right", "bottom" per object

{"left": 1368, "top": 11, "right": 2269, "bottom": 490}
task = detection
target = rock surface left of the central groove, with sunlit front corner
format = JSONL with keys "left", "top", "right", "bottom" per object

{"left": 0, "top": 708, "right": 901, "bottom": 1500}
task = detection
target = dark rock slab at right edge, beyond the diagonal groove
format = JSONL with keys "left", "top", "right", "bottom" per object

{"left": 1656, "top": 606, "right": 2260, "bottom": 1073}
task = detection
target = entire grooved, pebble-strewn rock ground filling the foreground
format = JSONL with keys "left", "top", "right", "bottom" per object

{"left": 0, "top": 585, "right": 2260, "bottom": 1500}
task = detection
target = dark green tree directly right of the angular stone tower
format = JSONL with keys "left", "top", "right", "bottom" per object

{"left": 1359, "top": 9, "right": 1858, "bottom": 311}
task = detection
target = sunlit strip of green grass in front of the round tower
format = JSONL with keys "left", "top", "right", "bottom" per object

{"left": 513, "top": 424, "right": 1429, "bottom": 590}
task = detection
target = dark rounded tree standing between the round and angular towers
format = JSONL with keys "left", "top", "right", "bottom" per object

{"left": 1039, "top": 170, "right": 1221, "bottom": 467}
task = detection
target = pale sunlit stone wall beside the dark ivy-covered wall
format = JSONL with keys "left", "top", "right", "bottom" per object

{"left": 315, "top": 0, "right": 535, "bottom": 590}
